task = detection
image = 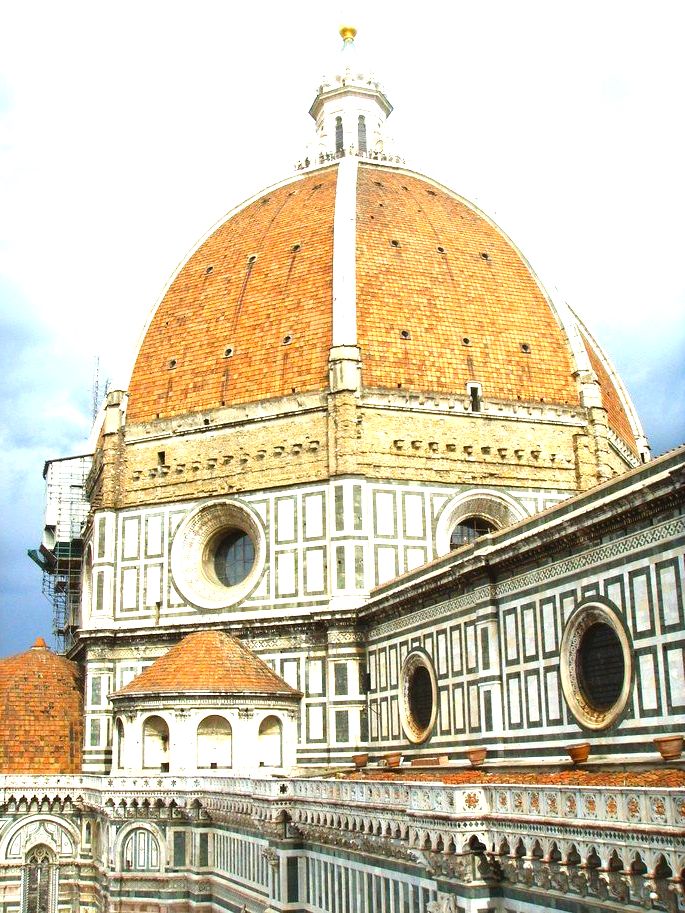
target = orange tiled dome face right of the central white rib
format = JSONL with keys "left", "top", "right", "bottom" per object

{"left": 357, "top": 165, "right": 579, "bottom": 405}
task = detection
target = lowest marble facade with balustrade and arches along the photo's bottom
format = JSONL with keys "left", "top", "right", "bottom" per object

{"left": 0, "top": 775, "right": 684, "bottom": 913}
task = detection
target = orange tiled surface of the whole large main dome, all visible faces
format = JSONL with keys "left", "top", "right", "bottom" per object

{"left": 127, "top": 161, "right": 637, "bottom": 453}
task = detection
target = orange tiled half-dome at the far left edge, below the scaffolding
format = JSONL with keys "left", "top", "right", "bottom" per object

{"left": 0, "top": 637, "right": 83, "bottom": 774}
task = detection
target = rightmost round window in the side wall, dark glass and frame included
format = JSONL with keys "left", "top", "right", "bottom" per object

{"left": 561, "top": 603, "right": 632, "bottom": 729}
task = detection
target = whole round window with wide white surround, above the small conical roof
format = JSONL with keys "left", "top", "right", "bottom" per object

{"left": 171, "top": 500, "right": 266, "bottom": 609}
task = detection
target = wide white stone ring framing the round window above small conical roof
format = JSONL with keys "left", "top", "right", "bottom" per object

{"left": 171, "top": 499, "right": 266, "bottom": 610}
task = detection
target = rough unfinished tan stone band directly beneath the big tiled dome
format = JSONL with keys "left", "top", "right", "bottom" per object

{"left": 100, "top": 385, "right": 635, "bottom": 507}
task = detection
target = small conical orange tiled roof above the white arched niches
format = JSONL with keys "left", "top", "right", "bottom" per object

{"left": 113, "top": 631, "right": 299, "bottom": 697}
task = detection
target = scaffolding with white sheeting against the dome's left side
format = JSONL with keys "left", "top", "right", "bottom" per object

{"left": 29, "top": 454, "right": 92, "bottom": 653}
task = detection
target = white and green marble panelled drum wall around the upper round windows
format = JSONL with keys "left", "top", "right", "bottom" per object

{"left": 82, "top": 478, "right": 564, "bottom": 631}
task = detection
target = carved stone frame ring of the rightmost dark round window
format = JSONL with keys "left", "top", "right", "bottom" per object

{"left": 559, "top": 600, "right": 633, "bottom": 731}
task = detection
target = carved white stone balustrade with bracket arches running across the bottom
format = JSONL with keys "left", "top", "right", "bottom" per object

{"left": 0, "top": 773, "right": 685, "bottom": 878}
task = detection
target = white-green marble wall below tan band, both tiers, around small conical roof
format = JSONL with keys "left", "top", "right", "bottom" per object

{"left": 76, "top": 477, "right": 563, "bottom": 770}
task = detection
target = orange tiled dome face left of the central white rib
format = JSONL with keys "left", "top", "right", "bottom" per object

{"left": 127, "top": 166, "right": 337, "bottom": 422}
